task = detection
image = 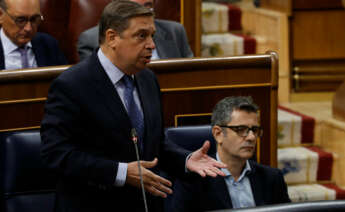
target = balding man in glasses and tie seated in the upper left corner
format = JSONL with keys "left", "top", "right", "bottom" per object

{"left": 0, "top": 0, "right": 67, "bottom": 70}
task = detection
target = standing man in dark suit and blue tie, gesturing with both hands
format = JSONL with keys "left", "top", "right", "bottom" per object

{"left": 41, "top": 0, "right": 225, "bottom": 212}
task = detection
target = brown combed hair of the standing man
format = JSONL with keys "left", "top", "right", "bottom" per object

{"left": 99, "top": 0, "right": 154, "bottom": 44}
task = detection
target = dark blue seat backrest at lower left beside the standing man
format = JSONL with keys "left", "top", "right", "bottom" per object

{"left": 0, "top": 130, "right": 56, "bottom": 212}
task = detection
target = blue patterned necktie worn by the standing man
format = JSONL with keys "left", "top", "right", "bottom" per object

{"left": 122, "top": 74, "right": 144, "bottom": 151}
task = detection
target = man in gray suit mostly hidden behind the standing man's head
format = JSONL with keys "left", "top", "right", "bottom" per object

{"left": 77, "top": 0, "right": 193, "bottom": 60}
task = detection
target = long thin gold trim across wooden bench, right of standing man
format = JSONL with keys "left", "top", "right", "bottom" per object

{"left": 161, "top": 83, "right": 272, "bottom": 92}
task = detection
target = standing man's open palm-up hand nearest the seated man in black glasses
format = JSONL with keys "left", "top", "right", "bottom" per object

{"left": 186, "top": 141, "right": 226, "bottom": 177}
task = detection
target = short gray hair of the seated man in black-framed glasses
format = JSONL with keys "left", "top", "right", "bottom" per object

{"left": 211, "top": 96, "right": 259, "bottom": 126}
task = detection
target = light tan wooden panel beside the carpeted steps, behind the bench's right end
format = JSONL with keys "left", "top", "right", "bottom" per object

{"left": 241, "top": 6, "right": 290, "bottom": 102}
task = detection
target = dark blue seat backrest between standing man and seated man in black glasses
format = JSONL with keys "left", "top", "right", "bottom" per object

{"left": 165, "top": 125, "right": 216, "bottom": 154}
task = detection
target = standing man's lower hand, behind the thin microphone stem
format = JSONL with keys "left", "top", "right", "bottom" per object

{"left": 126, "top": 158, "right": 172, "bottom": 198}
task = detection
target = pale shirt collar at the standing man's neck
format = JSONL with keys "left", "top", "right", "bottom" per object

{"left": 97, "top": 48, "right": 124, "bottom": 85}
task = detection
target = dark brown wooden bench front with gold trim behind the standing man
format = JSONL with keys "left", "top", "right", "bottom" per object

{"left": 0, "top": 53, "right": 278, "bottom": 166}
